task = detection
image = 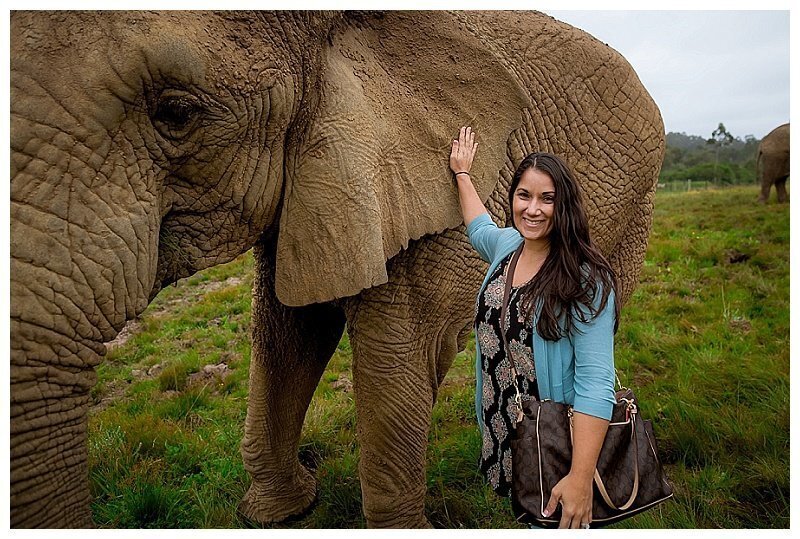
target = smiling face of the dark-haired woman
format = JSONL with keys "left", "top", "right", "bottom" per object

{"left": 512, "top": 168, "right": 556, "bottom": 245}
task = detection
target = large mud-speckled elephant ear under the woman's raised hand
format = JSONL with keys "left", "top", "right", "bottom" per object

{"left": 276, "top": 12, "right": 525, "bottom": 306}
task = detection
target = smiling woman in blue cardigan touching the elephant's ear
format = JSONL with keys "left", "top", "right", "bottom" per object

{"left": 450, "top": 127, "right": 619, "bottom": 528}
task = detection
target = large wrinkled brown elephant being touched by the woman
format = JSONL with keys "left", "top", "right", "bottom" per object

{"left": 10, "top": 11, "right": 665, "bottom": 527}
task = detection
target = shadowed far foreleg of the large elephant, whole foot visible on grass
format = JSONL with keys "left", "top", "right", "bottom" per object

{"left": 239, "top": 235, "right": 345, "bottom": 523}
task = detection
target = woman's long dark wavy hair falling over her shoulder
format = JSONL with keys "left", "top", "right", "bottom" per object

{"left": 508, "top": 152, "right": 619, "bottom": 341}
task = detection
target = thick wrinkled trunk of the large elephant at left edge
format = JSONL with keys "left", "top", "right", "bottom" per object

{"left": 10, "top": 80, "right": 161, "bottom": 527}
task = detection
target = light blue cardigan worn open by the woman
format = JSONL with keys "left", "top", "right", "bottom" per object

{"left": 467, "top": 213, "right": 616, "bottom": 432}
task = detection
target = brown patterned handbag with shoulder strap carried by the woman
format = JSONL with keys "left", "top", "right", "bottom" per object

{"left": 500, "top": 247, "right": 672, "bottom": 528}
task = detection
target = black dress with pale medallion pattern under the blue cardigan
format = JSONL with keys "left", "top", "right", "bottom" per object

{"left": 475, "top": 253, "right": 538, "bottom": 496}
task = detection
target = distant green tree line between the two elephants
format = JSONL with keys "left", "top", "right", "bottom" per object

{"left": 659, "top": 124, "right": 761, "bottom": 185}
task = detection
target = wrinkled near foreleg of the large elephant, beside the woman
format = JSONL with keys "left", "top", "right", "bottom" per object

{"left": 345, "top": 231, "right": 482, "bottom": 528}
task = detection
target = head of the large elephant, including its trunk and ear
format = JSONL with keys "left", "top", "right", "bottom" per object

{"left": 10, "top": 12, "right": 544, "bottom": 525}
